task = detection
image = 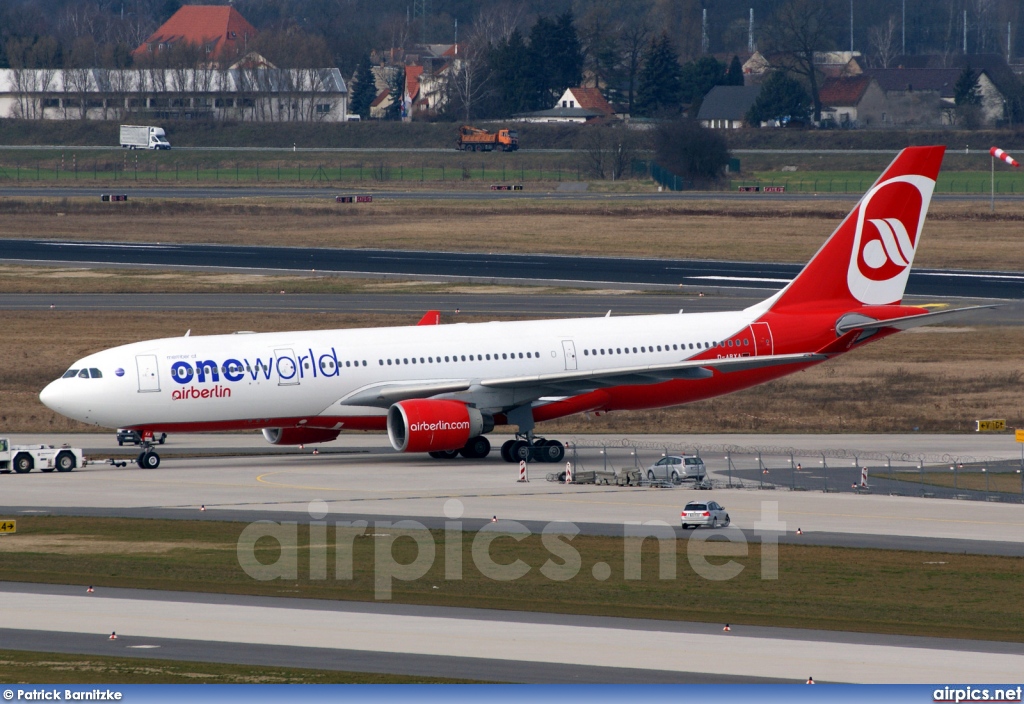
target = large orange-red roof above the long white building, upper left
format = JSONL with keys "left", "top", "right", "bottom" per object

{"left": 132, "top": 5, "right": 257, "bottom": 61}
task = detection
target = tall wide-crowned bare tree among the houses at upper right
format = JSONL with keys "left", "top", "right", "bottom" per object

{"left": 767, "top": 0, "right": 837, "bottom": 122}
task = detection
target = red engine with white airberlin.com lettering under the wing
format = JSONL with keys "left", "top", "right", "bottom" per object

{"left": 387, "top": 399, "right": 494, "bottom": 452}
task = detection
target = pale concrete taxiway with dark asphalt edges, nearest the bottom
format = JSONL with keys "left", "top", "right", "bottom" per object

{"left": 0, "top": 583, "right": 1024, "bottom": 684}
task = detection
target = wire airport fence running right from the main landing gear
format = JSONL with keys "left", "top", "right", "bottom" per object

{"left": 565, "top": 438, "right": 1024, "bottom": 503}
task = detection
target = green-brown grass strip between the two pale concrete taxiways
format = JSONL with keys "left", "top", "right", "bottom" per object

{"left": 0, "top": 517, "right": 1024, "bottom": 642}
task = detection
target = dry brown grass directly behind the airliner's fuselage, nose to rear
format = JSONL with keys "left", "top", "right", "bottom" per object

{"left": 0, "top": 311, "right": 1024, "bottom": 433}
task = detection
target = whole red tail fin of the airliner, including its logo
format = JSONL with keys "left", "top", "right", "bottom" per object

{"left": 771, "top": 146, "right": 945, "bottom": 310}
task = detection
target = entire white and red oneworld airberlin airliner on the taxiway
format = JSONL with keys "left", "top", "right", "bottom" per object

{"left": 40, "top": 146, "right": 983, "bottom": 468}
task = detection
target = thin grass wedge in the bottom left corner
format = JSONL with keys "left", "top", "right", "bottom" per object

{"left": 0, "top": 644, "right": 464, "bottom": 685}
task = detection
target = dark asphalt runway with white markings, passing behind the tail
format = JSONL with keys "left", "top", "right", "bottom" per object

{"left": 0, "top": 239, "right": 1024, "bottom": 299}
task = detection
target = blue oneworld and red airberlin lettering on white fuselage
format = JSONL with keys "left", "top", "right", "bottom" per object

{"left": 171, "top": 347, "right": 341, "bottom": 392}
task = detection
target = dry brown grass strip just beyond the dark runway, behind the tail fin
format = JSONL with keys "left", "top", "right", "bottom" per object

{"left": 0, "top": 199, "right": 1024, "bottom": 270}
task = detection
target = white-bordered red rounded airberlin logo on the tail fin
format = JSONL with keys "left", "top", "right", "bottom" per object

{"left": 847, "top": 174, "right": 935, "bottom": 305}
